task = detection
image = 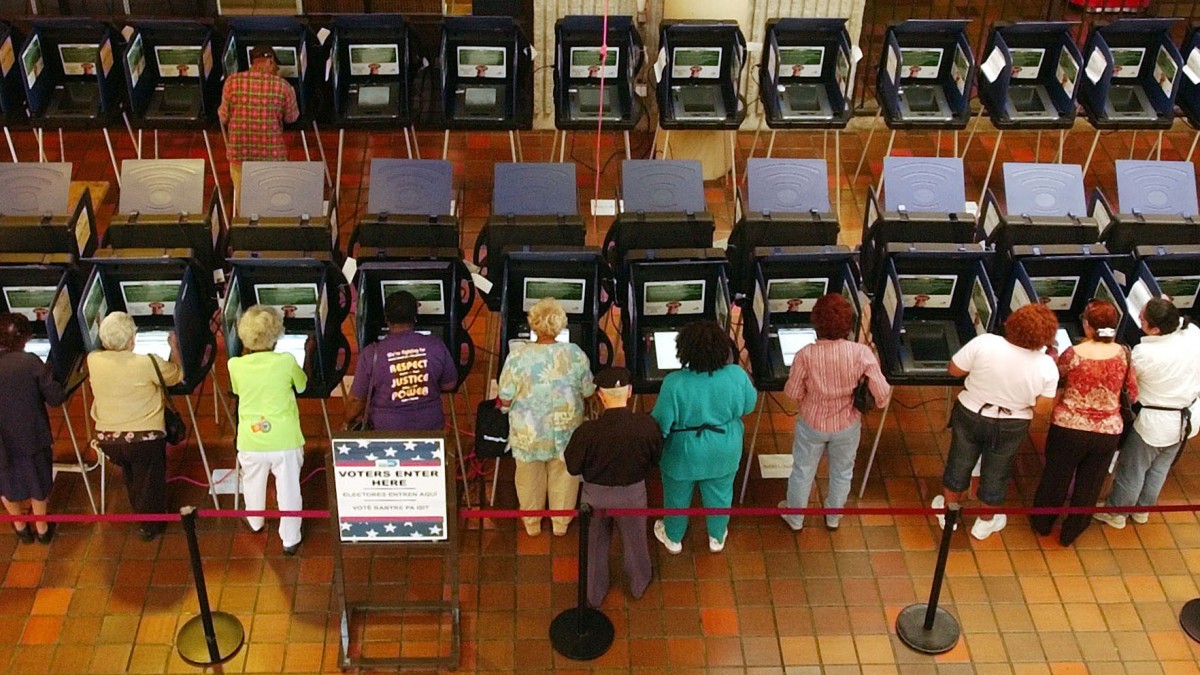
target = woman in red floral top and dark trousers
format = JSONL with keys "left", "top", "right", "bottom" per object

{"left": 1030, "top": 300, "right": 1138, "bottom": 546}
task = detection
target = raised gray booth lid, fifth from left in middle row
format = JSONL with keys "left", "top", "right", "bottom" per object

{"left": 492, "top": 162, "right": 580, "bottom": 216}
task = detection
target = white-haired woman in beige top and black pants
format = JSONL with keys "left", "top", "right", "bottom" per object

{"left": 88, "top": 312, "right": 184, "bottom": 542}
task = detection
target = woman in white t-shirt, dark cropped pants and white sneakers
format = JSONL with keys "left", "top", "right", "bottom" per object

{"left": 932, "top": 304, "right": 1058, "bottom": 539}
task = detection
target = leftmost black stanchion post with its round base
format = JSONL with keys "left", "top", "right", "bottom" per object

{"left": 175, "top": 507, "right": 246, "bottom": 665}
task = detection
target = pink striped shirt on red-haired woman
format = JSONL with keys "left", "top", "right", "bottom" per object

{"left": 784, "top": 340, "right": 892, "bottom": 434}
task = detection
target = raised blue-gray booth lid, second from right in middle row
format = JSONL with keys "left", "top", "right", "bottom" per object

{"left": 1004, "top": 162, "right": 1087, "bottom": 216}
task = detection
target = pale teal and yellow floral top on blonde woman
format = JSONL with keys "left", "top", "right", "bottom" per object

{"left": 500, "top": 342, "right": 595, "bottom": 461}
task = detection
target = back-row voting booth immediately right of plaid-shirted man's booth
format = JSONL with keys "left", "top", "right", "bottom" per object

{"left": 326, "top": 14, "right": 419, "bottom": 129}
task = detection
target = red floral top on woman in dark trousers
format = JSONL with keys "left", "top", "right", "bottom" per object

{"left": 1050, "top": 347, "right": 1138, "bottom": 435}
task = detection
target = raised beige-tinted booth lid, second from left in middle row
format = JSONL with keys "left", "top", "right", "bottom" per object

{"left": 116, "top": 160, "right": 204, "bottom": 214}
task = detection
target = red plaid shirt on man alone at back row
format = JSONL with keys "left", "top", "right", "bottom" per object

{"left": 217, "top": 68, "right": 300, "bottom": 162}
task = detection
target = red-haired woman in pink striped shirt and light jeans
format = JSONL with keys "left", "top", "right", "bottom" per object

{"left": 779, "top": 293, "right": 892, "bottom": 530}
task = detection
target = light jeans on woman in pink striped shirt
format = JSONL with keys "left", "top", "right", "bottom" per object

{"left": 784, "top": 417, "right": 863, "bottom": 527}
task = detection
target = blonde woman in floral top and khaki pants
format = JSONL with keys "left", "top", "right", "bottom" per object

{"left": 499, "top": 298, "right": 595, "bottom": 537}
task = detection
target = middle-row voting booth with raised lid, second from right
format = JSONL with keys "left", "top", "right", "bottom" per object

{"left": 979, "top": 162, "right": 1099, "bottom": 282}
